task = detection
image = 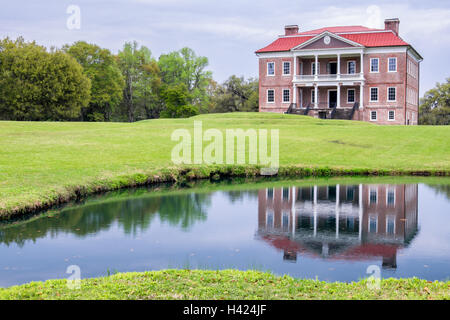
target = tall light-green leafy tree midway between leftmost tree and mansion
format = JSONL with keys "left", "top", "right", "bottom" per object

{"left": 158, "top": 48, "right": 212, "bottom": 112}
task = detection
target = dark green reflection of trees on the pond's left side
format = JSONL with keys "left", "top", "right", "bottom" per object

{"left": 0, "top": 193, "right": 211, "bottom": 246}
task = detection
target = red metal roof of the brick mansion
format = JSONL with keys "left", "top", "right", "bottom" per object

{"left": 256, "top": 26, "right": 409, "bottom": 53}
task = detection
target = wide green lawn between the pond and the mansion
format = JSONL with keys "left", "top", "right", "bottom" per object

{"left": 0, "top": 113, "right": 450, "bottom": 217}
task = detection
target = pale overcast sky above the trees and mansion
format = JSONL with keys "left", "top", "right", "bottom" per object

{"left": 0, "top": 0, "right": 450, "bottom": 95}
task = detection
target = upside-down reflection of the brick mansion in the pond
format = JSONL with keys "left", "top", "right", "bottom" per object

{"left": 258, "top": 184, "right": 418, "bottom": 268}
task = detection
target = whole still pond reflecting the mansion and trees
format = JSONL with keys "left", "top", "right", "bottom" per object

{"left": 0, "top": 179, "right": 450, "bottom": 287}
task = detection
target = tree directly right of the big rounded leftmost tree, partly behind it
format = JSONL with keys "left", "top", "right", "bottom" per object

{"left": 63, "top": 41, "right": 125, "bottom": 121}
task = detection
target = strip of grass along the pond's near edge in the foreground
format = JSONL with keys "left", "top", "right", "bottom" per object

{"left": 0, "top": 270, "right": 450, "bottom": 300}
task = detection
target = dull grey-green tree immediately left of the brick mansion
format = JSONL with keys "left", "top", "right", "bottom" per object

{"left": 210, "top": 75, "right": 259, "bottom": 112}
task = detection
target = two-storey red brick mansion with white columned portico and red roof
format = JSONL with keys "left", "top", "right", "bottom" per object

{"left": 256, "top": 18, "right": 422, "bottom": 125}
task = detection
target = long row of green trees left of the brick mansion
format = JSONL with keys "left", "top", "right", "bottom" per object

{"left": 0, "top": 38, "right": 258, "bottom": 122}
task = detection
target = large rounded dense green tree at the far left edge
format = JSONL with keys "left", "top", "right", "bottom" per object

{"left": 0, "top": 38, "right": 91, "bottom": 121}
